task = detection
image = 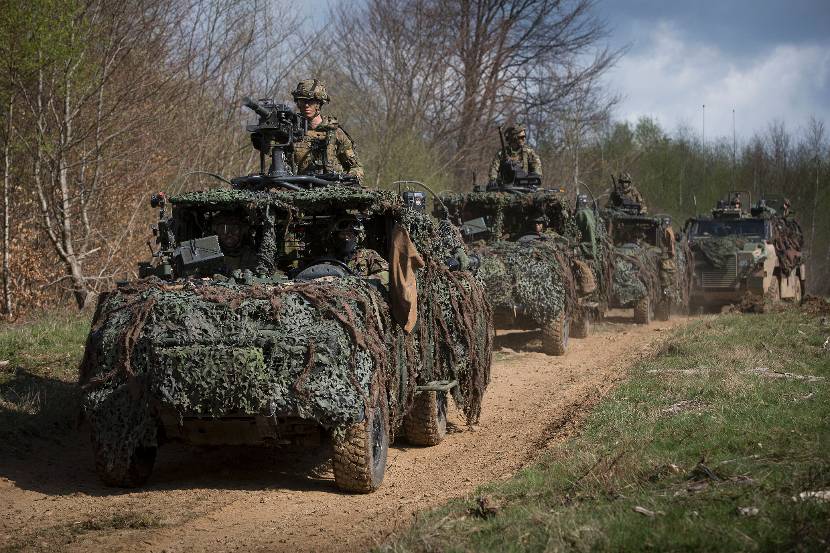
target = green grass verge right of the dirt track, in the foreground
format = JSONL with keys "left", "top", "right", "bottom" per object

{"left": 383, "top": 311, "right": 830, "bottom": 552}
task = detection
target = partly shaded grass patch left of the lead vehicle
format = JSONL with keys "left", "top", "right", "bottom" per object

{"left": 0, "top": 313, "right": 89, "bottom": 451}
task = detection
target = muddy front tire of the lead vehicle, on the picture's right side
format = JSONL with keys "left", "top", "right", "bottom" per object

{"left": 333, "top": 387, "right": 389, "bottom": 493}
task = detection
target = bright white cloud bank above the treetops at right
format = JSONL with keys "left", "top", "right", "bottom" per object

{"left": 609, "top": 21, "right": 830, "bottom": 141}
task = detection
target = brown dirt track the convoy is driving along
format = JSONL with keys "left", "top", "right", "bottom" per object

{"left": 0, "top": 312, "right": 683, "bottom": 552}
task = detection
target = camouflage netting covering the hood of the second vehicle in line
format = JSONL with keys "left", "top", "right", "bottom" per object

{"left": 476, "top": 240, "right": 577, "bottom": 326}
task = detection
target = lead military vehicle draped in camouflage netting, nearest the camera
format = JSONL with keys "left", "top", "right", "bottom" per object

{"left": 80, "top": 98, "right": 493, "bottom": 492}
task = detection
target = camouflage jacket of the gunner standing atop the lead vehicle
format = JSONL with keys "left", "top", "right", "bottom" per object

{"left": 294, "top": 117, "right": 364, "bottom": 184}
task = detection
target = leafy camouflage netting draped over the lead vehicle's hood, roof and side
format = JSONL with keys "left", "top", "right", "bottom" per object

{"left": 80, "top": 187, "right": 493, "bottom": 474}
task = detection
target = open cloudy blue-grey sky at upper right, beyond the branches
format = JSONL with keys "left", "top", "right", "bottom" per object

{"left": 596, "top": 0, "right": 830, "bottom": 141}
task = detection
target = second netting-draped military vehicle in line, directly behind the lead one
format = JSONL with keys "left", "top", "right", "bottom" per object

{"left": 435, "top": 186, "right": 604, "bottom": 355}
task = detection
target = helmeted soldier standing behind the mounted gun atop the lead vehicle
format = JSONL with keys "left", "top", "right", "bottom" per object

{"left": 291, "top": 79, "right": 364, "bottom": 184}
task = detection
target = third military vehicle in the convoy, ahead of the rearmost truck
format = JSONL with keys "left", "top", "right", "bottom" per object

{"left": 606, "top": 204, "right": 690, "bottom": 324}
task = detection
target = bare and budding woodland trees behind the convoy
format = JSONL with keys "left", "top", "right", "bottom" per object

{"left": 0, "top": 0, "right": 830, "bottom": 319}
